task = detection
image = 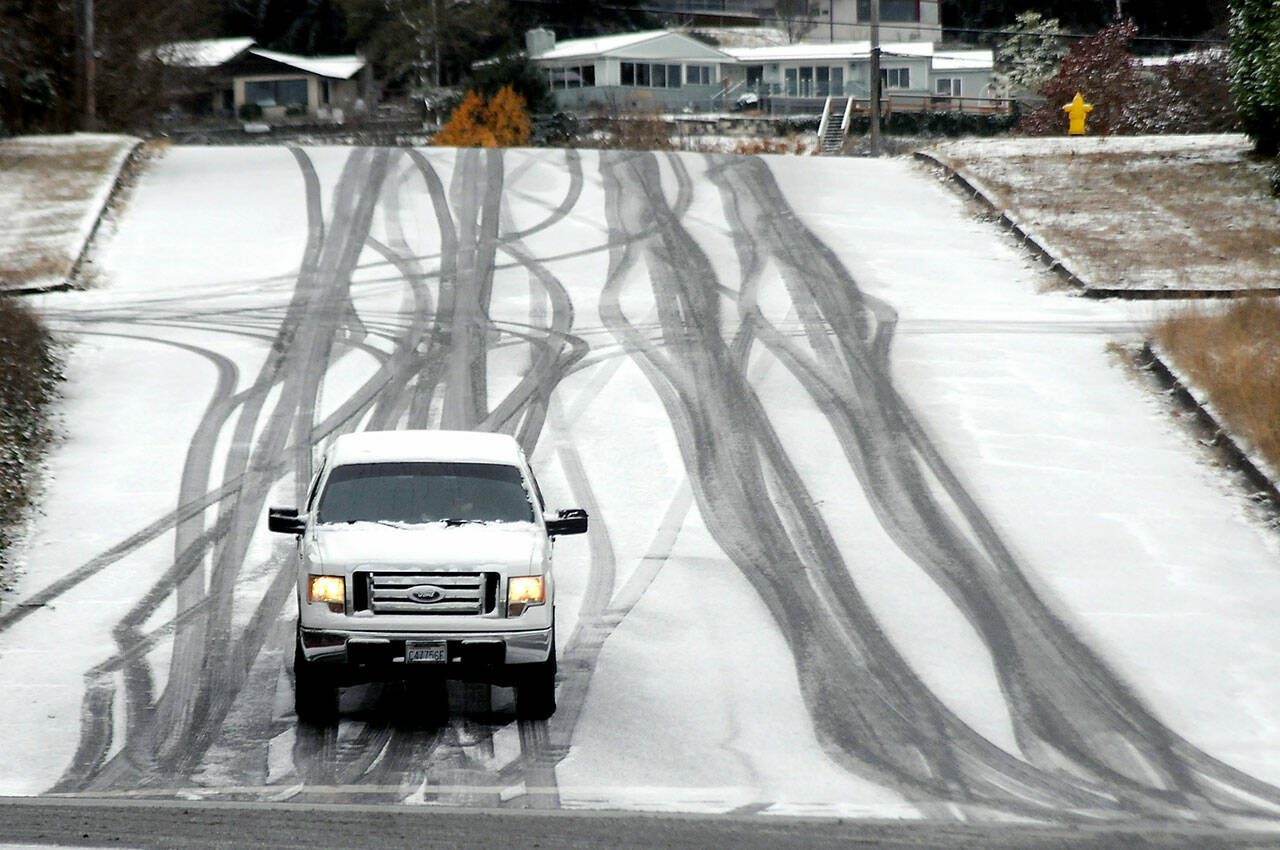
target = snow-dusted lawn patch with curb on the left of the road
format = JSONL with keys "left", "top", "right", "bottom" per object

{"left": 0, "top": 133, "right": 138, "bottom": 288}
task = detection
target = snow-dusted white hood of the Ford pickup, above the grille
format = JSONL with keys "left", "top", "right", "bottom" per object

{"left": 306, "top": 522, "right": 547, "bottom": 573}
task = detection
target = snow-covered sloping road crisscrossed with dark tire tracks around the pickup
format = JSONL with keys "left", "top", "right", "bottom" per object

{"left": 0, "top": 147, "right": 1280, "bottom": 824}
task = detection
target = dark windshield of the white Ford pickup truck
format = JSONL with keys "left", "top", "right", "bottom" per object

{"left": 317, "top": 462, "right": 534, "bottom": 524}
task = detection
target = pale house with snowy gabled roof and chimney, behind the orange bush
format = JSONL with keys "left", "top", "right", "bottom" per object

{"left": 525, "top": 29, "right": 735, "bottom": 111}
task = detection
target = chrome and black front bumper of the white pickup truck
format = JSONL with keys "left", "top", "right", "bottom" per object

{"left": 298, "top": 629, "right": 554, "bottom": 680}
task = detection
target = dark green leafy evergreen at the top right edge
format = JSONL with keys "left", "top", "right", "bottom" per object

{"left": 1231, "top": 0, "right": 1280, "bottom": 156}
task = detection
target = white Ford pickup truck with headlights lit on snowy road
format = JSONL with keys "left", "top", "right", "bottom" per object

{"left": 268, "top": 430, "right": 588, "bottom": 723}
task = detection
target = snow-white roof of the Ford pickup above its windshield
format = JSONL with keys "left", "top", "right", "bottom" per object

{"left": 329, "top": 430, "right": 521, "bottom": 466}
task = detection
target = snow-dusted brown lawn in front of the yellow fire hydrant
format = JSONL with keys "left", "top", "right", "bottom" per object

{"left": 932, "top": 134, "right": 1280, "bottom": 291}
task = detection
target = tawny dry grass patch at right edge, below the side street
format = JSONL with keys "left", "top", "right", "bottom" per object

{"left": 1155, "top": 298, "right": 1280, "bottom": 470}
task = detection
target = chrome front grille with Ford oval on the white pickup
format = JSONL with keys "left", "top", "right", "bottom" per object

{"left": 352, "top": 571, "right": 498, "bottom": 614}
